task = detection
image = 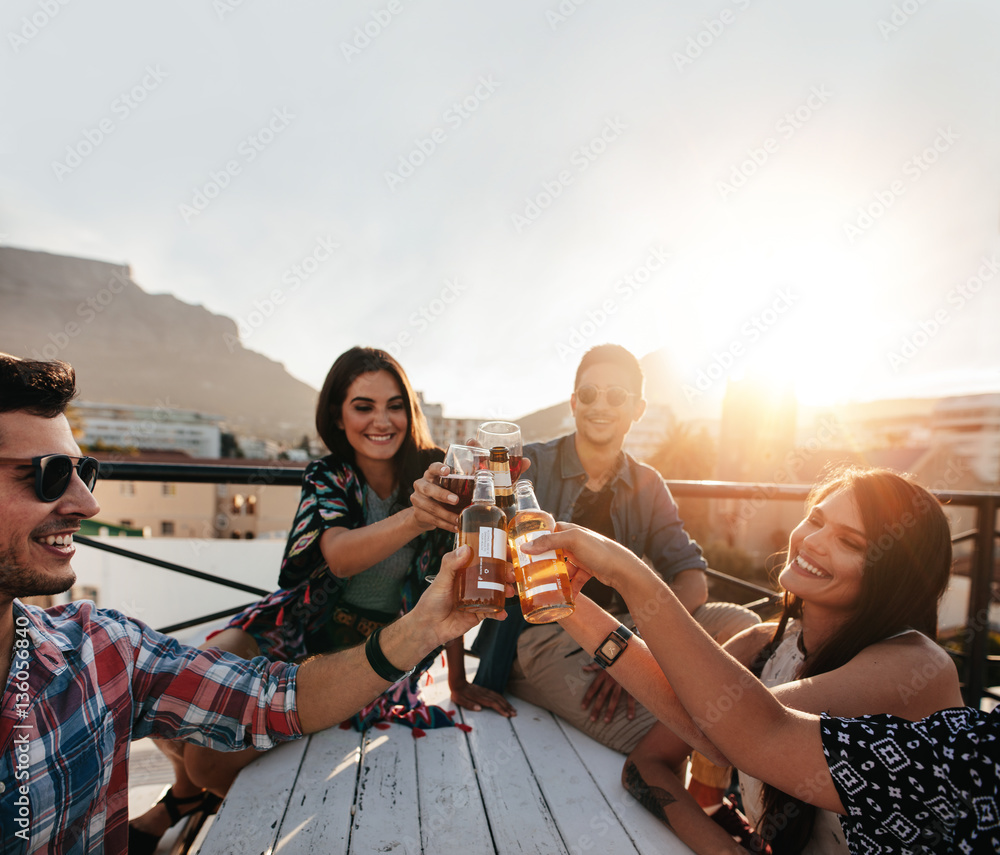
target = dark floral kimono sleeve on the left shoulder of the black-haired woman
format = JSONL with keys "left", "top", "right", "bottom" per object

{"left": 278, "top": 457, "right": 364, "bottom": 588}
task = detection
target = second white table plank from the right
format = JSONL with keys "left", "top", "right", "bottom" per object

{"left": 511, "top": 698, "right": 636, "bottom": 855}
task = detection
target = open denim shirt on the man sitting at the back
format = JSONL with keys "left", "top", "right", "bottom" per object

{"left": 472, "top": 434, "right": 708, "bottom": 692}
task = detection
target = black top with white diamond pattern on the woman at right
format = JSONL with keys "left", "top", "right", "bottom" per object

{"left": 820, "top": 707, "right": 1000, "bottom": 855}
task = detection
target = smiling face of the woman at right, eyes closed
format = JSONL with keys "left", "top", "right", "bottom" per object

{"left": 778, "top": 489, "right": 868, "bottom": 611}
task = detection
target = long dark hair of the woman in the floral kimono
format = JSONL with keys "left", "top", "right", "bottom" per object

{"left": 316, "top": 347, "right": 434, "bottom": 505}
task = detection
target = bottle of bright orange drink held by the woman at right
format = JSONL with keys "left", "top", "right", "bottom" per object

{"left": 507, "top": 478, "right": 575, "bottom": 623}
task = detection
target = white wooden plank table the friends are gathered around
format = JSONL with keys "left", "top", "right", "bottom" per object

{"left": 192, "top": 661, "right": 691, "bottom": 855}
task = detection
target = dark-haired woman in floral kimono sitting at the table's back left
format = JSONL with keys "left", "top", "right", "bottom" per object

{"left": 130, "top": 347, "right": 503, "bottom": 852}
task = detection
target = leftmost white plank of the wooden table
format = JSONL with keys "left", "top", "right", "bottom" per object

{"left": 190, "top": 739, "right": 308, "bottom": 855}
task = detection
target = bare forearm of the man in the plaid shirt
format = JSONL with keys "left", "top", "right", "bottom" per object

{"left": 296, "top": 613, "right": 438, "bottom": 733}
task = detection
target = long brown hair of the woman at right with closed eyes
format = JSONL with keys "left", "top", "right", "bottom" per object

{"left": 758, "top": 467, "right": 951, "bottom": 855}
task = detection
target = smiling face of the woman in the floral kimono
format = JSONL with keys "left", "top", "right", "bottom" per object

{"left": 338, "top": 371, "right": 409, "bottom": 469}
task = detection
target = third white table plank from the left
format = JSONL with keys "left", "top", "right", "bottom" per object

{"left": 350, "top": 724, "right": 421, "bottom": 855}
